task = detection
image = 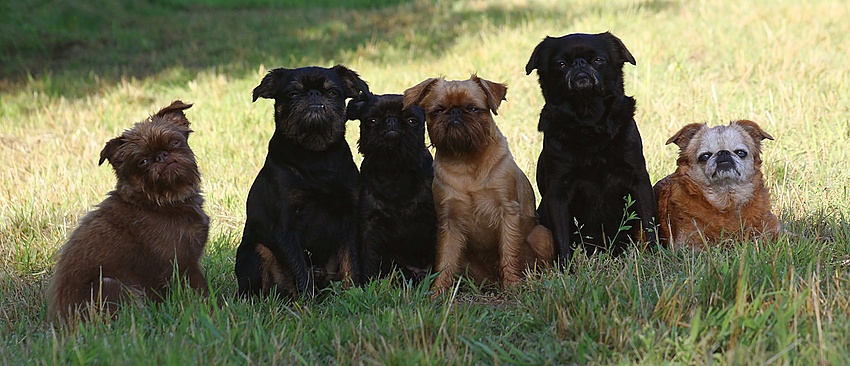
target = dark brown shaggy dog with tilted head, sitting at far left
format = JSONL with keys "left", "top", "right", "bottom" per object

{"left": 47, "top": 100, "right": 209, "bottom": 320}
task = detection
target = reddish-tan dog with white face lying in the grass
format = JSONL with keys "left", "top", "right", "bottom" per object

{"left": 654, "top": 120, "right": 782, "bottom": 250}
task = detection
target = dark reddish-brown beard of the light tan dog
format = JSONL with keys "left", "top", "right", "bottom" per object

{"left": 428, "top": 121, "right": 492, "bottom": 155}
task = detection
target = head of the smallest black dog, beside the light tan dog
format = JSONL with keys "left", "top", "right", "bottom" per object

{"left": 347, "top": 94, "right": 425, "bottom": 156}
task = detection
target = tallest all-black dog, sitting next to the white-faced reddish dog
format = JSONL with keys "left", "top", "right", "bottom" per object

{"left": 525, "top": 32, "right": 656, "bottom": 268}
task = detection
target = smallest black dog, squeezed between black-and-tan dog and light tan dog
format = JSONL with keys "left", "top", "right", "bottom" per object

{"left": 347, "top": 94, "right": 437, "bottom": 282}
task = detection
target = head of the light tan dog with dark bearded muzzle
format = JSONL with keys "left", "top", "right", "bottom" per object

{"left": 404, "top": 75, "right": 507, "bottom": 155}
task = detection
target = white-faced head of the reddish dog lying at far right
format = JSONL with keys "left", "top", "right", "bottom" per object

{"left": 667, "top": 120, "right": 773, "bottom": 187}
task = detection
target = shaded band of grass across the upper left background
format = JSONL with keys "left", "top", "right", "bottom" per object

{"left": 0, "top": 0, "right": 672, "bottom": 98}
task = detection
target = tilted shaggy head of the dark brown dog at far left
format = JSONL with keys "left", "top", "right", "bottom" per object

{"left": 100, "top": 101, "right": 201, "bottom": 206}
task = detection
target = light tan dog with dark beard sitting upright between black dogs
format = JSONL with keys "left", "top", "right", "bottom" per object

{"left": 404, "top": 75, "right": 553, "bottom": 296}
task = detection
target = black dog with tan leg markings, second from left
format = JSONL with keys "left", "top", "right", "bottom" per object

{"left": 236, "top": 65, "right": 370, "bottom": 297}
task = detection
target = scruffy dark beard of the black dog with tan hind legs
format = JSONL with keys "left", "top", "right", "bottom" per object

{"left": 278, "top": 101, "right": 345, "bottom": 151}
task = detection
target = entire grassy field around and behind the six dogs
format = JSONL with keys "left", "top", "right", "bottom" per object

{"left": 0, "top": 0, "right": 850, "bottom": 365}
